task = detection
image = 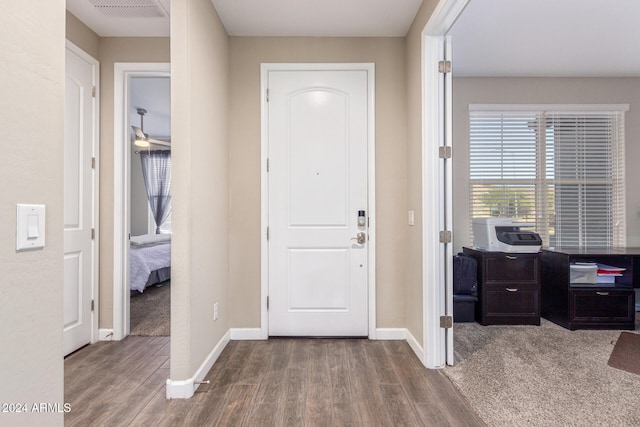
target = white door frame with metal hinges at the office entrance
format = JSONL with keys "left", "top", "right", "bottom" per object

{"left": 422, "top": 0, "right": 469, "bottom": 369}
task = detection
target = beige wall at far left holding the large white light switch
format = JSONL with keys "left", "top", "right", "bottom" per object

{"left": 0, "top": 0, "right": 65, "bottom": 426}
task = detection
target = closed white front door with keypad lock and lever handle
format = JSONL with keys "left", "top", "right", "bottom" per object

{"left": 268, "top": 69, "right": 370, "bottom": 336}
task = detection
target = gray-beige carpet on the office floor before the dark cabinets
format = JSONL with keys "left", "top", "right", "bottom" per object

{"left": 444, "top": 313, "right": 640, "bottom": 427}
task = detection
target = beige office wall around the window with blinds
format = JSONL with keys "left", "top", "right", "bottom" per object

{"left": 453, "top": 78, "right": 640, "bottom": 251}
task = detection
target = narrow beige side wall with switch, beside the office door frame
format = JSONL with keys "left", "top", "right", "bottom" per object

{"left": 404, "top": 0, "right": 437, "bottom": 345}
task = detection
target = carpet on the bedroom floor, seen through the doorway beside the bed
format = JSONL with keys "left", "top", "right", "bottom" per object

{"left": 129, "top": 281, "right": 171, "bottom": 337}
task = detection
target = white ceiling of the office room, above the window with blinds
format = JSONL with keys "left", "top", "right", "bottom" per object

{"left": 450, "top": 0, "right": 640, "bottom": 77}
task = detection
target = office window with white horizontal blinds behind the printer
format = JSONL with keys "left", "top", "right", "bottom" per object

{"left": 469, "top": 105, "right": 628, "bottom": 247}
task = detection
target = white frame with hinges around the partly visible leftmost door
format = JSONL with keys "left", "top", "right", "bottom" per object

{"left": 65, "top": 39, "right": 100, "bottom": 344}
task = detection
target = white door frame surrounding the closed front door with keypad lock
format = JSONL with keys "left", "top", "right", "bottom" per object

{"left": 255, "top": 63, "right": 376, "bottom": 339}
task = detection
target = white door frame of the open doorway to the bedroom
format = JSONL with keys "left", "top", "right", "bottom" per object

{"left": 113, "top": 62, "right": 171, "bottom": 340}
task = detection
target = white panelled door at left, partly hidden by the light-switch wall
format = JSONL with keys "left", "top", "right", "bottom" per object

{"left": 63, "top": 47, "right": 96, "bottom": 355}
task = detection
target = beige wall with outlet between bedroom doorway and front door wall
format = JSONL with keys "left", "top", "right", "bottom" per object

{"left": 171, "top": 0, "right": 231, "bottom": 380}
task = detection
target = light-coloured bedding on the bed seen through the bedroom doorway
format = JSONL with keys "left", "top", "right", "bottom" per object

{"left": 129, "top": 242, "right": 171, "bottom": 292}
